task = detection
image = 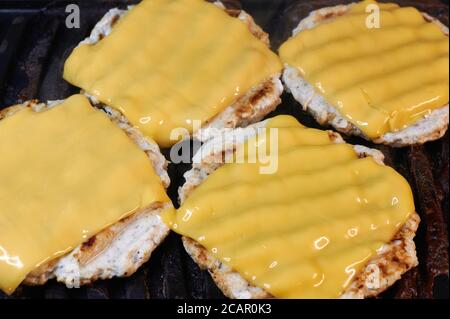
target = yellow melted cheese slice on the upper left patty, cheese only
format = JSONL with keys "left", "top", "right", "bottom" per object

{"left": 64, "top": 0, "right": 282, "bottom": 147}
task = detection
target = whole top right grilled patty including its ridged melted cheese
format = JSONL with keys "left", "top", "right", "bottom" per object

{"left": 279, "top": 0, "right": 449, "bottom": 147}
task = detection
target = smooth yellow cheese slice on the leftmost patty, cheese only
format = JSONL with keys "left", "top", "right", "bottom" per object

{"left": 0, "top": 95, "right": 169, "bottom": 293}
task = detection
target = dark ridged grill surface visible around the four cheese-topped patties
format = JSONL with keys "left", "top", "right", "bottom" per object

{"left": 0, "top": 0, "right": 449, "bottom": 299}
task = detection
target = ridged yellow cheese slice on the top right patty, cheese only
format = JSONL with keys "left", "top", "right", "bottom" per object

{"left": 279, "top": 1, "right": 449, "bottom": 139}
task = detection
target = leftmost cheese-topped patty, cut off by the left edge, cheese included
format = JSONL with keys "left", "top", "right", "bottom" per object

{"left": 0, "top": 95, "right": 172, "bottom": 294}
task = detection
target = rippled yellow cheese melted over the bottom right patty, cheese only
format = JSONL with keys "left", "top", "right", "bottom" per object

{"left": 163, "top": 116, "right": 414, "bottom": 298}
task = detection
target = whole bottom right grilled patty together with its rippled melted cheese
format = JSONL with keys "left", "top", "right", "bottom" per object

{"left": 167, "top": 116, "right": 419, "bottom": 298}
